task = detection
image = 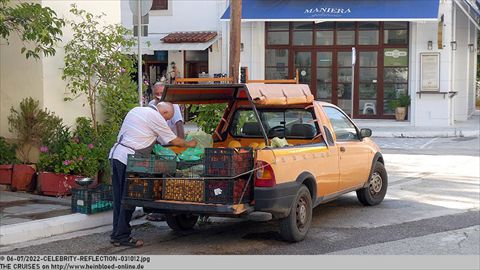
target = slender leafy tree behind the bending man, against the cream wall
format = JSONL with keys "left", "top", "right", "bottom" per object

{"left": 63, "top": 5, "right": 136, "bottom": 132}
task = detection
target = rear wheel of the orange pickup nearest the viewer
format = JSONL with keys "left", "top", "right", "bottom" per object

{"left": 280, "top": 185, "right": 313, "bottom": 242}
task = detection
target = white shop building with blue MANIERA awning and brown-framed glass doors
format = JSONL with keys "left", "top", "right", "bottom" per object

{"left": 222, "top": 0, "right": 479, "bottom": 126}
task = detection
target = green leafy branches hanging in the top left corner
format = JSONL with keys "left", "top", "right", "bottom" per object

{"left": 0, "top": 0, "right": 65, "bottom": 59}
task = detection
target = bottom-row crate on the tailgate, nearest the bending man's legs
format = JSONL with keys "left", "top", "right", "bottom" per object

{"left": 126, "top": 177, "right": 163, "bottom": 201}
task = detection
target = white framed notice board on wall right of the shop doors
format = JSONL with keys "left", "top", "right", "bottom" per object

{"left": 420, "top": 53, "right": 440, "bottom": 91}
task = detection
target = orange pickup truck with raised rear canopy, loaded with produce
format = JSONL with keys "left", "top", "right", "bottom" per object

{"left": 123, "top": 84, "right": 388, "bottom": 242}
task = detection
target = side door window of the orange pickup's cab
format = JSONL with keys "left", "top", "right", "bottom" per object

{"left": 323, "top": 106, "right": 358, "bottom": 141}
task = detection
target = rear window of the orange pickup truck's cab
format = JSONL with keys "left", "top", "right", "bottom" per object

{"left": 230, "top": 109, "right": 318, "bottom": 139}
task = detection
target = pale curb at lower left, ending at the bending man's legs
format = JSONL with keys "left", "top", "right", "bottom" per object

{"left": 0, "top": 211, "right": 112, "bottom": 246}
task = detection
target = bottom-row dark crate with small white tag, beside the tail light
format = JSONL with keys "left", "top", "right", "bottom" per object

{"left": 205, "top": 178, "right": 253, "bottom": 205}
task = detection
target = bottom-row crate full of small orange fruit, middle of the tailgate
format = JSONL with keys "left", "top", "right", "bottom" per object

{"left": 163, "top": 179, "right": 205, "bottom": 202}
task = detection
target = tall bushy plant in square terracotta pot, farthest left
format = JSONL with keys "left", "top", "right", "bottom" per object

{"left": 8, "top": 97, "right": 61, "bottom": 191}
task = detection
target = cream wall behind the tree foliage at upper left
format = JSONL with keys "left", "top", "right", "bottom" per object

{"left": 0, "top": 0, "right": 124, "bottom": 138}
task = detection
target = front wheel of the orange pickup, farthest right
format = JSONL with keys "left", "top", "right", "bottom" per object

{"left": 357, "top": 162, "right": 388, "bottom": 206}
